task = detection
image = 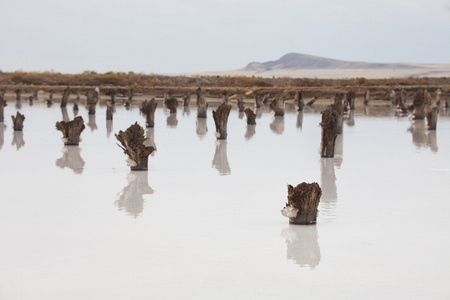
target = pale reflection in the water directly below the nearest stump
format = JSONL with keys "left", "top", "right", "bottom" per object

{"left": 281, "top": 224, "right": 321, "bottom": 269}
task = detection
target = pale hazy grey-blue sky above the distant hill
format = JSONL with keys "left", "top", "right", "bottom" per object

{"left": 0, "top": 0, "right": 450, "bottom": 73}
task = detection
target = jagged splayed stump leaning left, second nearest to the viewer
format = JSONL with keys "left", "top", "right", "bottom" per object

{"left": 116, "top": 122, "right": 156, "bottom": 171}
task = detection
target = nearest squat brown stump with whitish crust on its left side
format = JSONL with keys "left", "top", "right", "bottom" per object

{"left": 281, "top": 182, "right": 322, "bottom": 225}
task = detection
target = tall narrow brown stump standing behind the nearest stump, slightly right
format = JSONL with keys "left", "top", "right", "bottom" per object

{"left": 320, "top": 105, "right": 339, "bottom": 157}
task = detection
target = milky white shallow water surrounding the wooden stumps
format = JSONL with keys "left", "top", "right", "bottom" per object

{"left": 0, "top": 102, "right": 450, "bottom": 300}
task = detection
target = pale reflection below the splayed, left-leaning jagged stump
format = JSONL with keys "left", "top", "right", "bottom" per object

{"left": 114, "top": 171, "right": 154, "bottom": 219}
